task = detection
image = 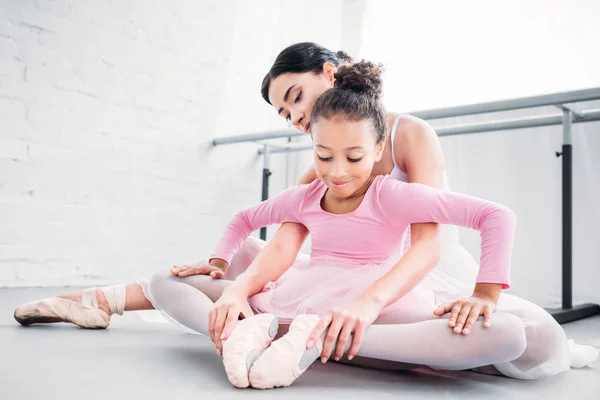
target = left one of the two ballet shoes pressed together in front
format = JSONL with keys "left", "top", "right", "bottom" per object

{"left": 223, "top": 314, "right": 279, "bottom": 388}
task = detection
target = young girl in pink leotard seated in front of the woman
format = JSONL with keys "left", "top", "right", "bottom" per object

{"left": 162, "top": 62, "right": 595, "bottom": 388}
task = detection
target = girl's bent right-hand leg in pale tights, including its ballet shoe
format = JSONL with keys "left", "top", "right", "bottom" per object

{"left": 250, "top": 313, "right": 526, "bottom": 388}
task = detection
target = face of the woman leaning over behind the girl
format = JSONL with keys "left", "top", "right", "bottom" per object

{"left": 269, "top": 63, "right": 336, "bottom": 133}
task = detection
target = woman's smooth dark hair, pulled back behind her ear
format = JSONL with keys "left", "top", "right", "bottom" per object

{"left": 260, "top": 42, "right": 353, "bottom": 104}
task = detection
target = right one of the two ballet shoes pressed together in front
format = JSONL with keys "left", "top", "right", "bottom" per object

{"left": 249, "top": 314, "right": 323, "bottom": 389}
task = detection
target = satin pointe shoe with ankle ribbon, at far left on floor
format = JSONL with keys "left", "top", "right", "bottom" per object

{"left": 14, "top": 285, "right": 125, "bottom": 329}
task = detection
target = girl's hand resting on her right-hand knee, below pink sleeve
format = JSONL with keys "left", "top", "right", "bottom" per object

{"left": 433, "top": 292, "right": 496, "bottom": 335}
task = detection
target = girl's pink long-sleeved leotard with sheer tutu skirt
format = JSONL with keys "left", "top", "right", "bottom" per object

{"left": 211, "top": 176, "right": 516, "bottom": 318}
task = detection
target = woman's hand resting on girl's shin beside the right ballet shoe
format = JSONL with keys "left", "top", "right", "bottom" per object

{"left": 306, "top": 298, "right": 382, "bottom": 363}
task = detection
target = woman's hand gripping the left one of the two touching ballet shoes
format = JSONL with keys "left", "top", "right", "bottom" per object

{"left": 208, "top": 288, "right": 254, "bottom": 355}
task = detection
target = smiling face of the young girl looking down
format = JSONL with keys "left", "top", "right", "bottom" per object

{"left": 312, "top": 118, "right": 385, "bottom": 198}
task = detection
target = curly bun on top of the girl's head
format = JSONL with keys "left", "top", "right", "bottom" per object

{"left": 334, "top": 61, "right": 383, "bottom": 99}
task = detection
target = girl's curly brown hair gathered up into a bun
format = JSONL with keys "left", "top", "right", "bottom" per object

{"left": 310, "top": 61, "right": 387, "bottom": 144}
